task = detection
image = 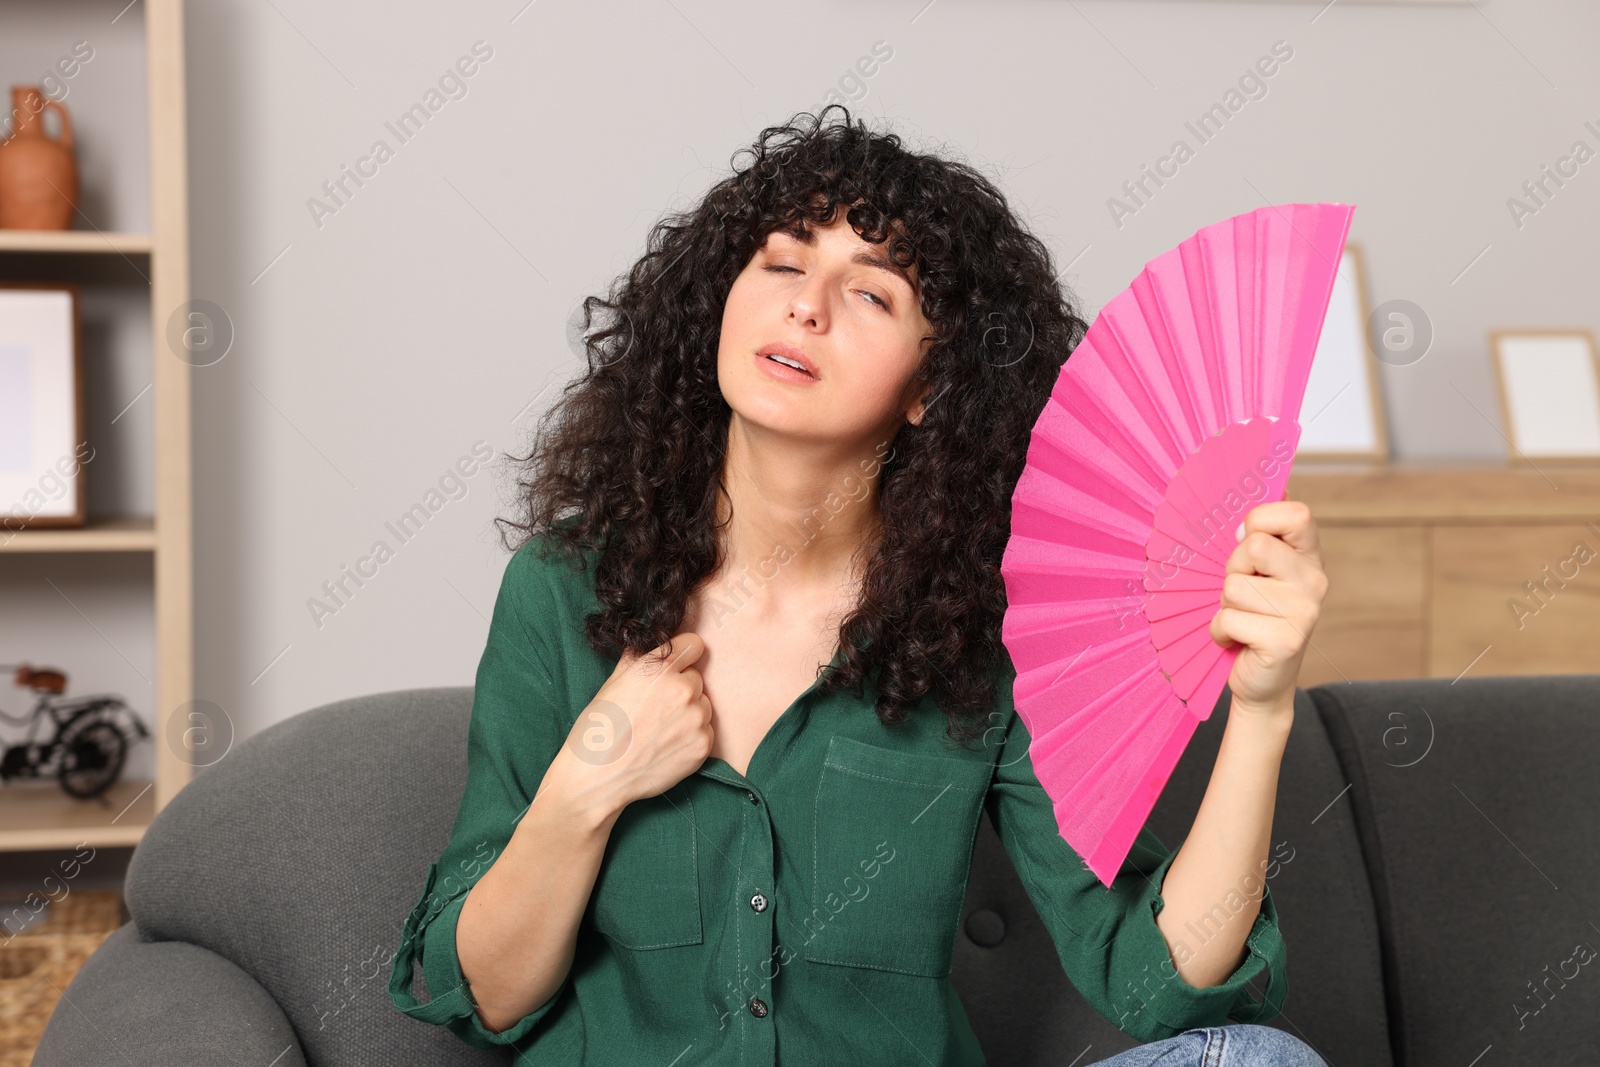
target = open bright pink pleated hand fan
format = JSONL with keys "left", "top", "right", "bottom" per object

{"left": 1000, "top": 203, "right": 1355, "bottom": 886}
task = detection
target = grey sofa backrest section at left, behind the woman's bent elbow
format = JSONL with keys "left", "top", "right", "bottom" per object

{"left": 125, "top": 686, "right": 510, "bottom": 1067}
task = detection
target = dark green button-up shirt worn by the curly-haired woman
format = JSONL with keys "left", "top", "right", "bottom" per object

{"left": 389, "top": 539, "right": 1286, "bottom": 1067}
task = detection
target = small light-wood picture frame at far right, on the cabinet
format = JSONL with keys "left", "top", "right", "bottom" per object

{"left": 1490, "top": 326, "right": 1600, "bottom": 467}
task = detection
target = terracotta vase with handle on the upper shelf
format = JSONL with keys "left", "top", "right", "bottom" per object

{"left": 0, "top": 85, "right": 78, "bottom": 230}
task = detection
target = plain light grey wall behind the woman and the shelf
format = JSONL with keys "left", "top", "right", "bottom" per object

{"left": 0, "top": 0, "right": 1600, "bottom": 790}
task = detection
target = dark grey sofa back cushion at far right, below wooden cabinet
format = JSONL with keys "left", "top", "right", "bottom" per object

{"left": 1312, "top": 675, "right": 1600, "bottom": 1067}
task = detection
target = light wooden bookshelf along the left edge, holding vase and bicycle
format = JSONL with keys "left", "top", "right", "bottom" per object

{"left": 0, "top": 0, "right": 194, "bottom": 851}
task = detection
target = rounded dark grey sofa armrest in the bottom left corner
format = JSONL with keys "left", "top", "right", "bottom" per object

{"left": 34, "top": 923, "right": 306, "bottom": 1067}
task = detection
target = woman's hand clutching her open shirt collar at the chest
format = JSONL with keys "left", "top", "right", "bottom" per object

{"left": 566, "top": 630, "right": 714, "bottom": 811}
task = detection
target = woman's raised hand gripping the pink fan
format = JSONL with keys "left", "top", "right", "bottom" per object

{"left": 1211, "top": 501, "right": 1328, "bottom": 713}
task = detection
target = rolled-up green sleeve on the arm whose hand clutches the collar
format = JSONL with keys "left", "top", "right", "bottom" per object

{"left": 389, "top": 542, "right": 571, "bottom": 1048}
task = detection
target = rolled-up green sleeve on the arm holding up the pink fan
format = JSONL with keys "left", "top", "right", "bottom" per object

{"left": 986, "top": 709, "right": 1288, "bottom": 1041}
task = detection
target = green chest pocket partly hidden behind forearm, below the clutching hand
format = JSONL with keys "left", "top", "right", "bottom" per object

{"left": 594, "top": 789, "right": 702, "bottom": 950}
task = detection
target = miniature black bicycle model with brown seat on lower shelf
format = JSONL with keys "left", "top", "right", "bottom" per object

{"left": 0, "top": 664, "right": 150, "bottom": 800}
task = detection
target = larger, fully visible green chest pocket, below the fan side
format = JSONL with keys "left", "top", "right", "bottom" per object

{"left": 800, "top": 736, "right": 994, "bottom": 977}
